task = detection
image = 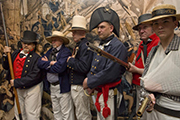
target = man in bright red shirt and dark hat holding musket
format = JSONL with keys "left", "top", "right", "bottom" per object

{"left": 129, "top": 13, "right": 159, "bottom": 120}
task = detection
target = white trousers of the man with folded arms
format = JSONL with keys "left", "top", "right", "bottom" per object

{"left": 50, "top": 85, "right": 75, "bottom": 120}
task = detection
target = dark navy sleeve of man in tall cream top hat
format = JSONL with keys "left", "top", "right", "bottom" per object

{"left": 68, "top": 45, "right": 93, "bottom": 73}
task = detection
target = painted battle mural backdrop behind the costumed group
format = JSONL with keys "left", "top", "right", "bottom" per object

{"left": 0, "top": 0, "right": 180, "bottom": 120}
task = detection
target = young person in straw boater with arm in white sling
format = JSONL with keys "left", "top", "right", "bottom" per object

{"left": 141, "top": 4, "right": 180, "bottom": 120}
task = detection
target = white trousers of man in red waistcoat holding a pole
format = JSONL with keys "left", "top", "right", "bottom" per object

{"left": 14, "top": 82, "right": 43, "bottom": 120}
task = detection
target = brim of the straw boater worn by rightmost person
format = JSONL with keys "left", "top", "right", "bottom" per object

{"left": 142, "top": 14, "right": 180, "bottom": 23}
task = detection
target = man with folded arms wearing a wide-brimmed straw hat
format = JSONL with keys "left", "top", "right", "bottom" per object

{"left": 38, "top": 31, "right": 74, "bottom": 120}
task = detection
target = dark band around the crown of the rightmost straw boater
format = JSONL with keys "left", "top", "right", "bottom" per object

{"left": 152, "top": 9, "right": 176, "bottom": 17}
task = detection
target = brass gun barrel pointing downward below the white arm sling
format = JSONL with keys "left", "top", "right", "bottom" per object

{"left": 136, "top": 96, "right": 151, "bottom": 117}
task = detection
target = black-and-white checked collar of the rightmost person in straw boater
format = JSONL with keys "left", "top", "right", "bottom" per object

{"left": 165, "top": 34, "right": 180, "bottom": 54}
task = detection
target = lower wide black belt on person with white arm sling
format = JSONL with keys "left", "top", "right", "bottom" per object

{"left": 154, "top": 104, "right": 180, "bottom": 118}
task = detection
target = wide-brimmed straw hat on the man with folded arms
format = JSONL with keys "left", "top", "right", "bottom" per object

{"left": 46, "top": 31, "right": 69, "bottom": 45}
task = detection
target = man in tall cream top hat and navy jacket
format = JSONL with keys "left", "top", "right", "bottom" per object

{"left": 67, "top": 15, "right": 92, "bottom": 120}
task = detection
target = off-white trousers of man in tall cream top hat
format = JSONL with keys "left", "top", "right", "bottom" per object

{"left": 71, "top": 85, "right": 92, "bottom": 120}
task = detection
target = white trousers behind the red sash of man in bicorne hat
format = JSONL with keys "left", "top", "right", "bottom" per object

{"left": 97, "top": 89, "right": 122, "bottom": 120}
